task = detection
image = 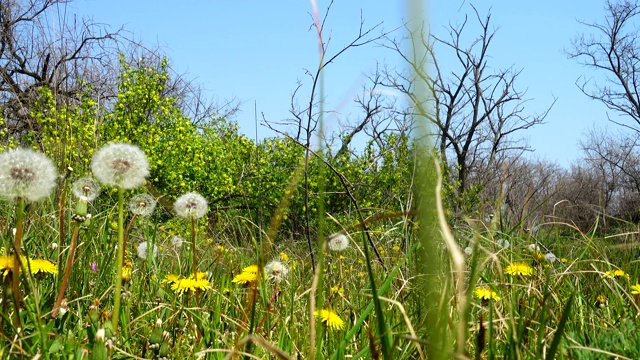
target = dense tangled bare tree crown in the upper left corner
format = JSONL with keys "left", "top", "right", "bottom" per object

{"left": 0, "top": 0, "right": 119, "bottom": 138}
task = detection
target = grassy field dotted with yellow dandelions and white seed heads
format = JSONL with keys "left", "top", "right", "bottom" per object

{"left": 0, "top": 144, "right": 640, "bottom": 359}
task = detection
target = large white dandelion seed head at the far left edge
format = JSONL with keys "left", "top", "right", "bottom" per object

{"left": 0, "top": 148, "right": 58, "bottom": 202}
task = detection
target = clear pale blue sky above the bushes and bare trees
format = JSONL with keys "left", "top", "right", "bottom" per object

{"left": 70, "top": 0, "right": 616, "bottom": 166}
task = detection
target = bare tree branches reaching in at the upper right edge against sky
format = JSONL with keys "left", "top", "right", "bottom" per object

{"left": 568, "top": 0, "right": 640, "bottom": 131}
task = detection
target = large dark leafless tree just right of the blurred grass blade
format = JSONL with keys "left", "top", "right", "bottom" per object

{"left": 386, "top": 7, "right": 553, "bottom": 212}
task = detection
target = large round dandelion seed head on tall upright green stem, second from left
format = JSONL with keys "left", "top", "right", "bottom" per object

{"left": 91, "top": 143, "right": 149, "bottom": 190}
